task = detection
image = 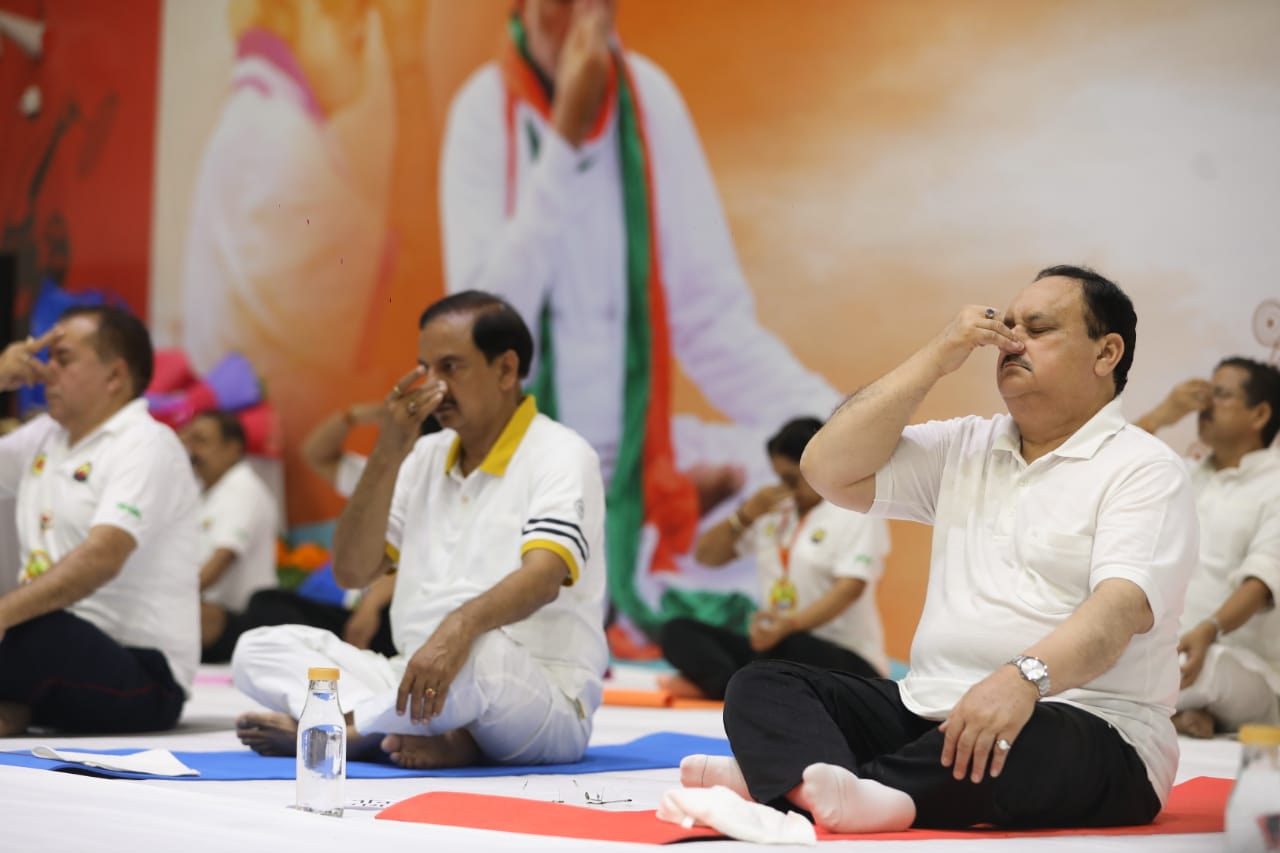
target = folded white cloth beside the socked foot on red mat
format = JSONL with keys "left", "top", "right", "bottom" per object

{"left": 658, "top": 785, "right": 818, "bottom": 844}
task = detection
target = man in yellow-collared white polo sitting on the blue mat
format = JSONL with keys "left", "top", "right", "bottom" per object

{"left": 232, "top": 291, "right": 608, "bottom": 767}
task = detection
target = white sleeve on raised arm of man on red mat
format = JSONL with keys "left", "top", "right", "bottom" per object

{"left": 868, "top": 418, "right": 962, "bottom": 524}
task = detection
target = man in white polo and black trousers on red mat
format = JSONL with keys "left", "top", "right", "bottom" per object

{"left": 682, "top": 266, "right": 1198, "bottom": 833}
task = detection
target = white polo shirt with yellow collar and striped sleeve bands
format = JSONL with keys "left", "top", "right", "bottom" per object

{"left": 387, "top": 396, "right": 608, "bottom": 713}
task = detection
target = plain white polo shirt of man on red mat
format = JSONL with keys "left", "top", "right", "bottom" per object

{"left": 872, "top": 398, "right": 1198, "bottom": 802}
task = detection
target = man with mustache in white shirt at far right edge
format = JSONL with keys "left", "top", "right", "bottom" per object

{"left": 1138, "top": 357, "right": 1280, "bottom": 738}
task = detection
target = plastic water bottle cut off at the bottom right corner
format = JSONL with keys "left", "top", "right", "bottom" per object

{"left": 1226, "top": 725, "right": 1280, "bottom": 853}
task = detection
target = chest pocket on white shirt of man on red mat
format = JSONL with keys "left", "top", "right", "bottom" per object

{"left": 1014, "top": 526, "right": 1093, "bottom": 615}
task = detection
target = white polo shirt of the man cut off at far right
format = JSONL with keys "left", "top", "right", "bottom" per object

{"left": 1181, "top": 448, "right": 1280, "bottom": 693}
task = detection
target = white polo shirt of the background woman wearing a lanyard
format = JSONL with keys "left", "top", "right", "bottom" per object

{"left": 736, "top": 501, "right": 888, "bottom": 675}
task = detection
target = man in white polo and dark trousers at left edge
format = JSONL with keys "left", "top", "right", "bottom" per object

{"left": 0, "top": 307, "right": 200, "bottom": 735}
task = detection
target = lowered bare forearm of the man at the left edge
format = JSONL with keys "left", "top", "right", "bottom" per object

{"left": 0, "top": 524, "right": 137, "bottom": 634}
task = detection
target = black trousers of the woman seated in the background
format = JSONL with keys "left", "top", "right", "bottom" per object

{"left": 660, "top": 619, "right": 879, "bottom": 699}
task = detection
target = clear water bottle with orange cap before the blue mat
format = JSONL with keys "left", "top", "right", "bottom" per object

{"left": 297, "top": 666, "right": 347, "bottom": 817}
